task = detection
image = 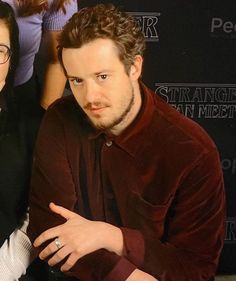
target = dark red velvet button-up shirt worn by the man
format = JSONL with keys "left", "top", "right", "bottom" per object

{"left": 28, "top": 82, "right": 225, "bottom": 281}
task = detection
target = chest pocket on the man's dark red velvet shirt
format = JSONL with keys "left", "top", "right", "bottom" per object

{"left": 127, "top": 191, "right": 173, "bottom": 239}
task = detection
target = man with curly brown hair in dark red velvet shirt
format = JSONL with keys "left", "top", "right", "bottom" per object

{"left": 28, "top": 4, "right": 225, "bottom": 281}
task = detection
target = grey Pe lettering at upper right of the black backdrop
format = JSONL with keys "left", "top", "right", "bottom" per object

{"left": 210, "top": 17, "right": 236, "bottom": 38}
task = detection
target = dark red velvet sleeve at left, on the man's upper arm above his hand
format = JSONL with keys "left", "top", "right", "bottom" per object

{"left": 27, "top": 106, "right": 76, "bottom": 241}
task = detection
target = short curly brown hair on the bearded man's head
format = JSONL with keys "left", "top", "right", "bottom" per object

{"left": 58, "top": 4, "right": 145, "bottom": 73}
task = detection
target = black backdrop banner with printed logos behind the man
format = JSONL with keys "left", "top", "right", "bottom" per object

{"left": 79, "top": 0, "right": 236, "bottom": 274}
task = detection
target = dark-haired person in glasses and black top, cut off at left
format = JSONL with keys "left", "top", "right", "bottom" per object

{"left": 0, "top": 1, "right": 44, "bottom": 281}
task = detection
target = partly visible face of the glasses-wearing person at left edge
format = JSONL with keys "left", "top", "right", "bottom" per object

{"left": 0, "top": 20, "right": 10, "bottom": 91}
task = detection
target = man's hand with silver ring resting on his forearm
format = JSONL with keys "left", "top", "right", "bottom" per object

{"left": 34, "top": 203, "right": 123, "bottom": 271}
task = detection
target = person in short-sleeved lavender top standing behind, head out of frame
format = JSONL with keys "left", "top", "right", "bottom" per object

{"left": 5, "top": 0, "right": 77, "bottom": 110}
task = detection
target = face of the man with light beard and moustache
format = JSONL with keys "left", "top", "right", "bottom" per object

{"left": 62, "top": 39, "right": 142, "bottom": 134}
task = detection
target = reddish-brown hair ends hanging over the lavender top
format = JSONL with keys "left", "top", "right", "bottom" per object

{"left": 18, "top": 0, "right": 71, "bottom": 17}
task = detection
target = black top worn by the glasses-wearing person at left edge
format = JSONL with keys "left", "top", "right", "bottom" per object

{"left": 0, "top": 89, "right": 41, "bottom": 246}
